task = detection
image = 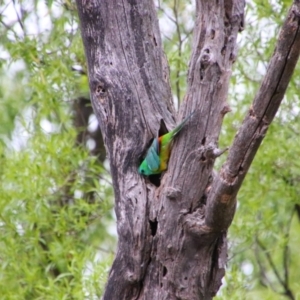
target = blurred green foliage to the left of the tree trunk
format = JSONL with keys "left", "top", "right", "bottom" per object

{"left": 0, "top": 1, "right": 115, "bottom": 300}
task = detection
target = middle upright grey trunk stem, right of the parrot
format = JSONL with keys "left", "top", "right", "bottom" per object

{"left": 141, "top": 0, "right": 245, "bottom": 299}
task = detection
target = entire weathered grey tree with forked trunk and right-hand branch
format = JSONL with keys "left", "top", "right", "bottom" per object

{"left": 77, "top": 0, "right": 300, "bottom": 300}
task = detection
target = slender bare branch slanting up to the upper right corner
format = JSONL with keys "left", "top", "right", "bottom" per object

{"left": 205, "top": 0, "right": 300, "bottom": 230}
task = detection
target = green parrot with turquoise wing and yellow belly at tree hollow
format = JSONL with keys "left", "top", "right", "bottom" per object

{"left": 138, "top": 112, "right": 194, "bottom": 176}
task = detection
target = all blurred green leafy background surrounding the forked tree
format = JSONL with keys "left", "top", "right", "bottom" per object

{"left": 0, "top": 0, "right": 300, "bottom": 300}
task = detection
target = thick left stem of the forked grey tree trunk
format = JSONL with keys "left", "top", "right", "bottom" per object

{"left": 77, "top": 0, "right": 174, "bottom": 300}
